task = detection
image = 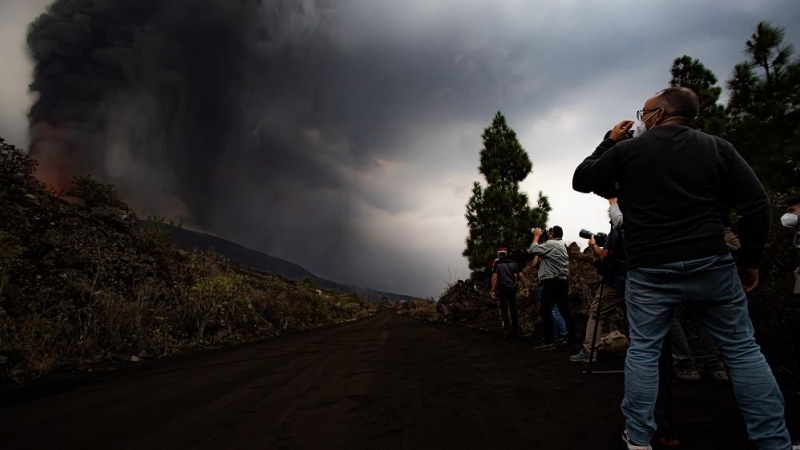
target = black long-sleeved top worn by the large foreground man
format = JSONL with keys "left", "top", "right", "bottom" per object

{"left": 572, "top": 125, "right": 770, "bottom": 268}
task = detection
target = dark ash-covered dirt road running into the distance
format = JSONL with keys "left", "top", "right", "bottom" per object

{"left": 0, "top": 311, "right": 800, "bottom": 450}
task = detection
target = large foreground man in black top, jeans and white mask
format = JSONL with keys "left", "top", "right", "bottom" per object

{"left": 572, "top": 88, "right": 792, "bottom": 450}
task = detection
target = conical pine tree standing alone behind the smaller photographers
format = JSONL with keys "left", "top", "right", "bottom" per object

{"left": 463, "top": 112, "right": 550, "bottom": 281}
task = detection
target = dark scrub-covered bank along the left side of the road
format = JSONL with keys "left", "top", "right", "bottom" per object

{"left": 0, "top": 139, "right": 376, "bottom": 385}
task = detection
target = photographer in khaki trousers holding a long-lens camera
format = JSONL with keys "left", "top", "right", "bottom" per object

{"left": 569, "top": 198, "right": 626, "bottom": 363}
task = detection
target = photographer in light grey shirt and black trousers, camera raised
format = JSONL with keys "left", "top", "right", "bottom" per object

{"left": 528, "top": 226, "right": 575, "bottom": 351}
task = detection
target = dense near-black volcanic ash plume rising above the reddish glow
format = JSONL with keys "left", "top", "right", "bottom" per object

{"left": 28, "top": 0, "right": 328, "bottom": 223}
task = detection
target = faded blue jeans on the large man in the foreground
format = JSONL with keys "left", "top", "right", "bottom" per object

{"left": 622, "top": 254, "right": 792, "bottom": 450}
